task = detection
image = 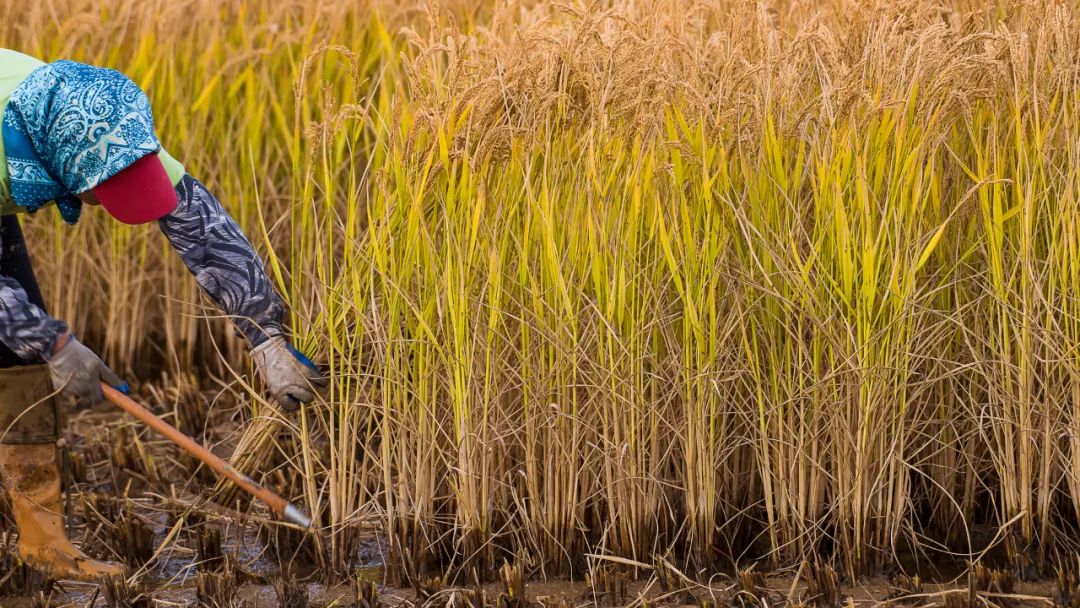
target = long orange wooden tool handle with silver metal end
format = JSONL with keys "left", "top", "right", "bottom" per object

{"left": 102, "top": 382, "right": 310, "bottom": 527}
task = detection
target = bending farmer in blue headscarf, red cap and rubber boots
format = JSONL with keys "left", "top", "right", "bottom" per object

{"left": 0, "top": 49, "right": 323, "bottom": 580}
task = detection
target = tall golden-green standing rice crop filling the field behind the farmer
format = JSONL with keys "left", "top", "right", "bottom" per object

{"left": 6, "top": 0, "right": 1080, "bottom": 591}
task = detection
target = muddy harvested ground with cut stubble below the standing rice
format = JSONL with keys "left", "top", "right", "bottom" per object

{"left": 0, "top": 388, "right": 1067, "bottom": 608}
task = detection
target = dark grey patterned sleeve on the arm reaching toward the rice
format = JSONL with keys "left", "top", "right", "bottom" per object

{"left": 158, "top": 175, "right": 285, "bottom": 348}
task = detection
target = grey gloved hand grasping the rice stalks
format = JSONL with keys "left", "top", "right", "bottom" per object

{"left": 252, "top": 337, "right": 326, "bottom": 411}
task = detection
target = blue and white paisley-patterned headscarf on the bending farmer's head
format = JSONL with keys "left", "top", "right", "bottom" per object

{"left": 3, "top": 60, "right": 161, "bottom": 224}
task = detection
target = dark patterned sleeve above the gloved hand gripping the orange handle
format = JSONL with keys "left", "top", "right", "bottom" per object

{"left": 0, "top": 276, "right": 68, "bottom": 361}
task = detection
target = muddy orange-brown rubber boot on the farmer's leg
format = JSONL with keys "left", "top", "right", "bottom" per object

{"left": 0, "top": 444, "right": 124, "bottom": 581}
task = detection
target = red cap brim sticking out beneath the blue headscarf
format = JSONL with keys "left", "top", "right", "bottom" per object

{"left": 93, "top": 153, "right": 177, "bottom": 224}
